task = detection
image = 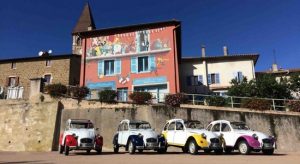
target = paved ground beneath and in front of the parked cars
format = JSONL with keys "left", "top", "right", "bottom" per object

{"left": 0, "top": 149, "right": 300, "bottom": 164}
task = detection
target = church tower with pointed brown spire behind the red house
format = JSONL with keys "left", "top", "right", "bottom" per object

{"left": 72, "top": 3, "right": 96, "bottom": 55}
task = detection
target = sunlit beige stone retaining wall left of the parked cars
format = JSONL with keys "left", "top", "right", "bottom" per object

{"left": 0, "top": 100, "right": 58, "bottom": 151}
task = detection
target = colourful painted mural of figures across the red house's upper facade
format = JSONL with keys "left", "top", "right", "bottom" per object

{"left": 87, "top": 28, "right": 170, "bottom": 59}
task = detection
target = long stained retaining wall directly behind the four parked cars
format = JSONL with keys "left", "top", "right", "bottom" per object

{"left": 61, "top": 102, "right": 300, "bottom": 151}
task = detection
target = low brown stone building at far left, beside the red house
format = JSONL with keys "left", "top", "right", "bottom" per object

{"left": 0, "top": 54, "right": 80, "bottom": 99}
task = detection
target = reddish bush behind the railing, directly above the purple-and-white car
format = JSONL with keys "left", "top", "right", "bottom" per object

{"left": 241, "top": 98, "right": 272, "bottom": 111}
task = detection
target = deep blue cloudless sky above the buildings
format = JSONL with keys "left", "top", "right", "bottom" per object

{"left": 0, "top": 0, "right": 300, "bottom": 71}
